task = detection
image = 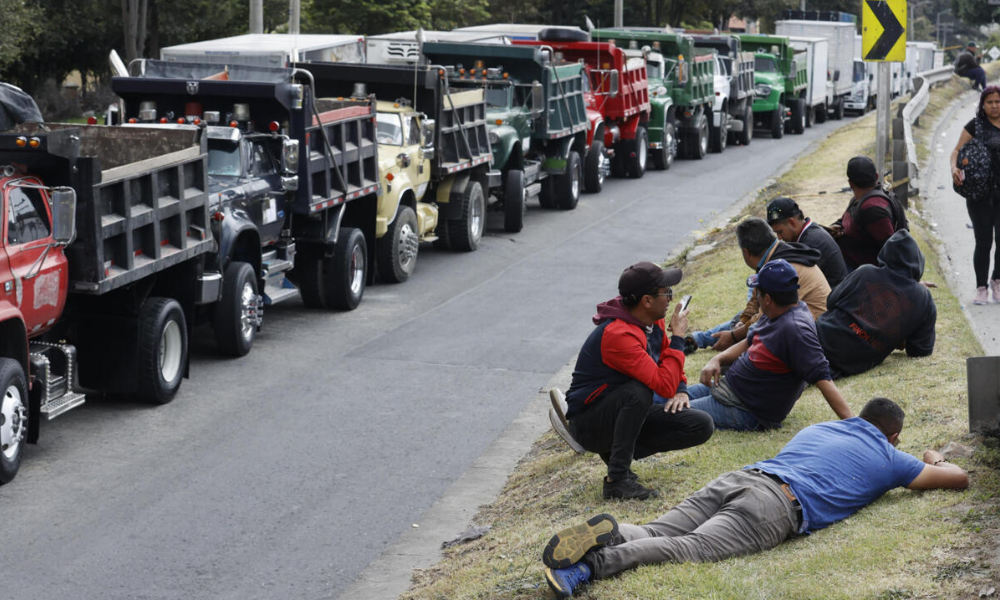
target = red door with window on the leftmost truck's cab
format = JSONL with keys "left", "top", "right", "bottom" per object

{"left": 3, "top": 179, "right": 68, "bottom": 336}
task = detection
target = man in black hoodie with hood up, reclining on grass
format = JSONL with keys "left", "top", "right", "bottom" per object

{"left": 816, "top": 230, "right": 937, "bottom": 375}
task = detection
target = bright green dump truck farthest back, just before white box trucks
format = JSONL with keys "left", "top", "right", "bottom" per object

{"left": 740, "top": 34, "right": 819, "bottom": 138}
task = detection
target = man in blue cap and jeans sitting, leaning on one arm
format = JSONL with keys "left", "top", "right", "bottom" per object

{"left": 688, "top": 258, "right": 854, "bottom": 431}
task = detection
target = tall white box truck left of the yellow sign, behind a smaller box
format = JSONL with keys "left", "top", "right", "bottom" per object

{"left": 774, "top": 20, "right": 855, "bottom": 119}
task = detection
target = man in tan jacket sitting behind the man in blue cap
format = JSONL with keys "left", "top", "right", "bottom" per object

{"left": 694, "top": 217, "right": 830, "bottom": 351}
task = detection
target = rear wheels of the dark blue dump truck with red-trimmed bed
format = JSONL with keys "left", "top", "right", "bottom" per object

{"left": 295, "top": 227, "right": 368, "bottom": 310}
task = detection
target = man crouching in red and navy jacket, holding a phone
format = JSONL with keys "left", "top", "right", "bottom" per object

{"left": 566, "top": 262, "right": 714, "bottom": 500}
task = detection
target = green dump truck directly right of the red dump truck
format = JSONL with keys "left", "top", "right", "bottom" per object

{"left": 591, "top": 27, "right": 727, "bottom": 162}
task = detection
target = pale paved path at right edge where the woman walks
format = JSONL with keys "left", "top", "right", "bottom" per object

{"left": 920, "top": 85, "right": 1000, "bottom": 356}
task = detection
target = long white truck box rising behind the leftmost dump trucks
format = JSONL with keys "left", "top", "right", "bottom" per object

{"left": 160, "top": 33, "right": 365, "bottom": 68}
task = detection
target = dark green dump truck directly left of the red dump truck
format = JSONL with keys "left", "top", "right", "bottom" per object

{"left": 423, "top": 42, "right": 588, "bottom": 232}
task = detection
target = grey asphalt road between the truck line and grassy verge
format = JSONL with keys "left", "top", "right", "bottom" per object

{"left": 0, "top": 121, "right": 846, "bottom": 600}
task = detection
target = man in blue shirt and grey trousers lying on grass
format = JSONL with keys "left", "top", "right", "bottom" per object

{"left": 542, "top": 398, "right": 969, "bottom": 598}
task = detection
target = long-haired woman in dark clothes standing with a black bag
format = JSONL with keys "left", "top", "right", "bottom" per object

{"left": 951, "top": 85, "right": 1000, "bottom": 304}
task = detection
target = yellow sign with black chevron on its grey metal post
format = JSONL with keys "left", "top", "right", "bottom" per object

{"left": 861, "top": 0, "right": 906, "bottom": 178}
